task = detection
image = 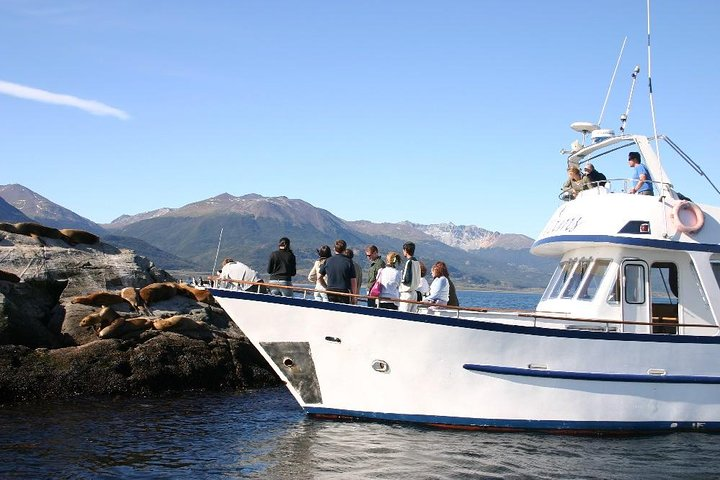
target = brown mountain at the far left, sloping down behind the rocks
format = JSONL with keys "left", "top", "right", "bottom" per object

{"left": 0, "top": 184, "right": 106, "bottom": 236}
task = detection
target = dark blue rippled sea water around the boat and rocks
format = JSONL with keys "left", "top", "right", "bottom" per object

{"left": 0, "top": 292, "right": 720, "bottom": 479}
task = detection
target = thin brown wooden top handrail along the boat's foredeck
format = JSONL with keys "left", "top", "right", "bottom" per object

{"left": 208, "top": 276, "right": 720, "bottom": 328}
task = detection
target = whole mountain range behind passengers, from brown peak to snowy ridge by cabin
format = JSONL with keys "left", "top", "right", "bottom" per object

{"left": 104, "top": 193, "right": 556, "bottom": 288}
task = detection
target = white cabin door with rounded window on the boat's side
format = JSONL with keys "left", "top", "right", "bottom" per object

{"left": 621, "top": 260, "right": 650, "bottom": 332}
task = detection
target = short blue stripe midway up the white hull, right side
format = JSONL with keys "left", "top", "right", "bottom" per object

{"left": 463, "top": 363, "right": 720, "bottom": 385}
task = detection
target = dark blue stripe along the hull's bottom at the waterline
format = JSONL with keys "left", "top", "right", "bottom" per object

{"left": 304, "top": 407, "right": 720, "bottom": 434}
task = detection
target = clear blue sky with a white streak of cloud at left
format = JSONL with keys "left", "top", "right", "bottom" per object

{"left": 0, "top": 0, "right": 720, "bottom": 238}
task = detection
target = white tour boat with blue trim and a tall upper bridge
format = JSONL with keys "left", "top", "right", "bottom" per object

{"left": 205, "top": 46, "right": 720, "bottom": 434}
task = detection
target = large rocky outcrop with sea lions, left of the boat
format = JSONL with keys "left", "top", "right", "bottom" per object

{"left": 0, "top": 225, "right": 279, "bottom": 402}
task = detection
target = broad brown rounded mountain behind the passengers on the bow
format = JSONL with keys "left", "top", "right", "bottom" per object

{"left": 105, "top": 193, "right": 366, "bottom": 272}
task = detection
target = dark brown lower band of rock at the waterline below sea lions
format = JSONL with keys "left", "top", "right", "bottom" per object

{"left": 0, "top": 333, "right": 279, "bottom": 402}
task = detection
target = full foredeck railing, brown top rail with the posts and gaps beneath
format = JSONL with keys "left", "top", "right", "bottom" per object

{"left": 208, "top": 277, "right": 720, "bottom": 332}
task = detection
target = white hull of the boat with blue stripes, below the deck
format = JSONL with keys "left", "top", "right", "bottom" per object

{"left": 212, "top": 290, "right": 720, "bottom": 432}
